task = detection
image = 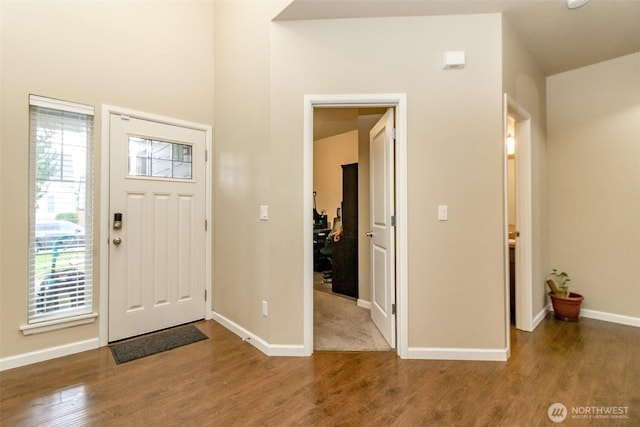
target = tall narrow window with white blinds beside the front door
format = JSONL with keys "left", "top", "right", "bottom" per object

{"left": 28, "top": 95, "right": 94, "bottom": 323}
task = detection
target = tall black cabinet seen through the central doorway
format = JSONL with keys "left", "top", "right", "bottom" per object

{"left": 331, "top": 163, "right": 358, "bottom": 298}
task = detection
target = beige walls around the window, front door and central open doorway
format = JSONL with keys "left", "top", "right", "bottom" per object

{"left": 0, "top": 1, "right": 544, "bottom": 366}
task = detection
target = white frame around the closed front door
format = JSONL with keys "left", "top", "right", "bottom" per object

{"left": 96, "top": 104, "right": 213, "bottom": 346}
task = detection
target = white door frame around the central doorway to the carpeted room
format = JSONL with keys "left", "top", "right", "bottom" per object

{"left": 302, "top": 93, "right": 409, "bottom": 359}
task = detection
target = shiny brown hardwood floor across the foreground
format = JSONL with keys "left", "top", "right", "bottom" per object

{"left": 0, "top": 316, "right": 640, "bottom": 426}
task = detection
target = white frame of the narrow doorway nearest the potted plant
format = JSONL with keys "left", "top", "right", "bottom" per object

{"left": 503, "top": 93, "right": 535, "bottom": 344}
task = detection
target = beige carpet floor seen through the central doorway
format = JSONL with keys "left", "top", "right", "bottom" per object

{"left": 313, "top": 276, "right": 390, "bottom": 351}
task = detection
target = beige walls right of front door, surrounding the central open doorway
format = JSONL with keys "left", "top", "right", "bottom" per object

{"left": 214, "top": 8, "right": 506, "bottom": 349}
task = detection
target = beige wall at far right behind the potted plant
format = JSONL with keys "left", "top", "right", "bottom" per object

{"left": 547, "top": 53, "right": 640, "bottom": 322}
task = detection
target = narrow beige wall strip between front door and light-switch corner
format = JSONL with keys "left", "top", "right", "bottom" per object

{"left": 212, "top": 1, "right": 288, "bottom": 342}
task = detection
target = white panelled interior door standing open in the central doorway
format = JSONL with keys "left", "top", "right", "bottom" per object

{"left": 368, "top": 108, "right": 396, "bottom": 347}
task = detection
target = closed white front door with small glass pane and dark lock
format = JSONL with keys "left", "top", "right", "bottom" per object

{"left": 105, "top": 114, "right": 206, "bottom": 341}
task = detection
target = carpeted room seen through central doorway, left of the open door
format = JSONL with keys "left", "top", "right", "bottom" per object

{"left": 313, "top": 107, "right": 391, "bottom": 351}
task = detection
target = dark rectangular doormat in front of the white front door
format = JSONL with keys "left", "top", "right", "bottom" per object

{"left": 110, "top": 325, "right": 209, "bottom": 365}
